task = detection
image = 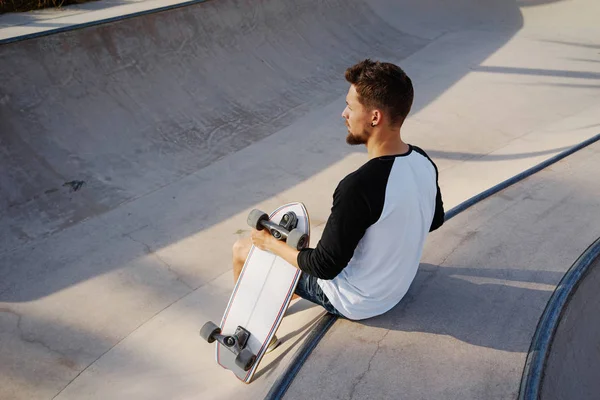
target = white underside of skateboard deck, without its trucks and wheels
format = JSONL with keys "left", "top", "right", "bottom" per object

{"left": 216, "top": 203, "right": 310, "bottom": 383}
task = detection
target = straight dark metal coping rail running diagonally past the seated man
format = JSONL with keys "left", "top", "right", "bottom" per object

{"left": 265, "top": 134, "right": 600, "bottom": 400}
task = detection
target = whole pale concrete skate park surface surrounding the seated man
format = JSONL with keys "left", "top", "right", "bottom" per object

{"left": 0, "top": 0, "right": 600, "bottom": 399}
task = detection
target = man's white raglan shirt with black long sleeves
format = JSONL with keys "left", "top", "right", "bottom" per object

{"left": 298, "top": 145, "right": 444, "bottom": 320}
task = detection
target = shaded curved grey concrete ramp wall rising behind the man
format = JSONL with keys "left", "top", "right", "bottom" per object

{"left": 0, "top": 0, "right": 430, "bottom": 252}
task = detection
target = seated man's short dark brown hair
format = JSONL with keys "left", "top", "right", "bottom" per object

{"left": 346, "top": 59, "right": 414, "bottom": 125}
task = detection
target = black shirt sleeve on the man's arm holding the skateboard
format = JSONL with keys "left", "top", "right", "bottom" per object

{"left": 298, "top": 170, "right": 387, "bottom": 280}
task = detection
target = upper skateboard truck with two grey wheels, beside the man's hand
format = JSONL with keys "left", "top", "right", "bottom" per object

{"left": 247, "top": 209, "right": 308, "bottom": 250}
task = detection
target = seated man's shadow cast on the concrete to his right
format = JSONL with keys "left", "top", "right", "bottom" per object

{"left": 358, "top": 264, "right": 563, "bottom": 352}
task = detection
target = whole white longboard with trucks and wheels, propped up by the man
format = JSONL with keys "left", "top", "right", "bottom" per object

{"left": 200, "top": 203, "right": 310, "bottom": 383}
